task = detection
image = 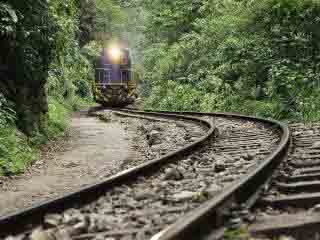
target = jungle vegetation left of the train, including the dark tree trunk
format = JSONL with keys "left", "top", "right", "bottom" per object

{"left": 0, "top": 0, "right": 125, "bottom": 175}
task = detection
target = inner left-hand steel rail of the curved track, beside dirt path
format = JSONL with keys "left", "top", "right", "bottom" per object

{"left": 0, "top": 108, "right": 215, "bottom": 237}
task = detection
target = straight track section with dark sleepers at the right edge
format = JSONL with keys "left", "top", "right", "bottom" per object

{"left": 249, "top": 124, "right": 320, "bottom": 240}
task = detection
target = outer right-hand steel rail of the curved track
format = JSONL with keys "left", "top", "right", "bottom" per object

{"left": 121, "top": 109, "right": 291, "bottom": 240}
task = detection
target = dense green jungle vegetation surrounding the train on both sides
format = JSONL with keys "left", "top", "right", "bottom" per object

{"left": 0, "top": 0, "right": 320, "bottom": 175}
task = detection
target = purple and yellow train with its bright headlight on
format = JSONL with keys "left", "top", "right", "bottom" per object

{"left": 93, "top": 47, "right": 137, "bottom": 107}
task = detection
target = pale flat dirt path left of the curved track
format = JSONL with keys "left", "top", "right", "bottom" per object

{"left": 0, "top": 114, "right": 138, "bottom": 215}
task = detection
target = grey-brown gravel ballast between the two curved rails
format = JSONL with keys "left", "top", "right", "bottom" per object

{"left": 3, "top": 114, "right": 279, "bottom": 240}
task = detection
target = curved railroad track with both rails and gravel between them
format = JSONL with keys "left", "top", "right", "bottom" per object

{"left": 0, "top": 109, "right": 289, "bottom": 240}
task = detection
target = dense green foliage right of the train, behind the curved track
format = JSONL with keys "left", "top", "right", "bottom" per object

{"left": 142, "top": 0, "right": 320, "bottom": 120}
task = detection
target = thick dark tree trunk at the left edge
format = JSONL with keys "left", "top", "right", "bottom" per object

{"left": 0, "top": 0, "right": 51, "bottom": 135}
